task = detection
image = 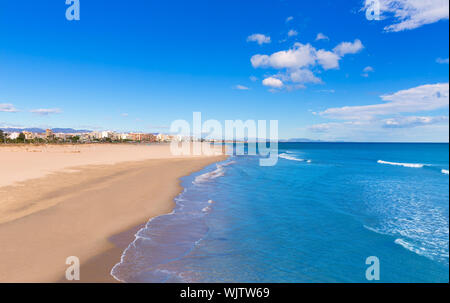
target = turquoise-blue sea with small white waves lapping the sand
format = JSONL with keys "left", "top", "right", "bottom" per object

{"left": 112, "top": 143, "right": 449, "bottom": 282}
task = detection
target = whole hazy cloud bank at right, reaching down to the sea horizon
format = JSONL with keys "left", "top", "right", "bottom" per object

{"left": 305, "top": 83, "right": 449, "bottom": 142}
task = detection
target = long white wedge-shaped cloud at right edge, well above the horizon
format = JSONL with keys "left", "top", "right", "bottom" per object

{"left": 320, "top": 83, "right": 449, "bottom": 120}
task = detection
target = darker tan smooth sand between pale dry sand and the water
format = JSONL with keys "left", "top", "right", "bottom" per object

{"left": 0, "top": 144, "right": 226, "bottom": 283}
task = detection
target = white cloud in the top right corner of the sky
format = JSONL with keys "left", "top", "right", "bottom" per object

{"left": 363, "top": 0, "right": 449, "bottom": 32}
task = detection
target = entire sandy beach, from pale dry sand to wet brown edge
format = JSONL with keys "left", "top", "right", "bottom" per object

{"left": 0, "top": 144, "right": 225, "bottom": 282}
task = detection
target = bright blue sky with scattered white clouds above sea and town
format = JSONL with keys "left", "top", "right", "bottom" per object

{"left": 0, "top": 0, "right": 449, "bottom": 142}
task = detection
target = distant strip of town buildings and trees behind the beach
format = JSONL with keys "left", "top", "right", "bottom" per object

{"left": 0, "top": 129, "right": 201, "bottom": 144}
